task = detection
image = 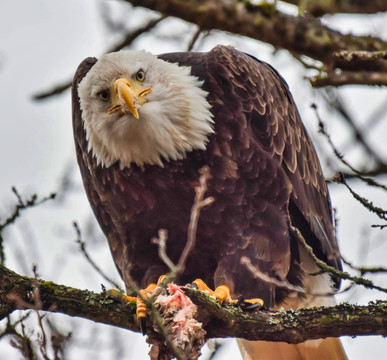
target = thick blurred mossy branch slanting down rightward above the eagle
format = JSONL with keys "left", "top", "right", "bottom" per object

{"left": 125, "top": 0, "right": 387, "bottom": 62}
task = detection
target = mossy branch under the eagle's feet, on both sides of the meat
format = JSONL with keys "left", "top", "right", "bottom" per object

{"left": 0, "top": 265, "right": 387, "bottom": 343}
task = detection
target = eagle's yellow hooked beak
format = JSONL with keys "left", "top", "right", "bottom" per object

{"left": 108, "top": 78, "right": 152, "bottom": 119}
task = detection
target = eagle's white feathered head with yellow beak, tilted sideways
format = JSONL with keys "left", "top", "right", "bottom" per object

{"left": 78, "top": 51, "right": 213, "bottom": 168}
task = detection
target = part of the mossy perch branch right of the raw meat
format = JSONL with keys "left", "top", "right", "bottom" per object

{"left": 185, "top": 289, "right": 387, "bottom": 344}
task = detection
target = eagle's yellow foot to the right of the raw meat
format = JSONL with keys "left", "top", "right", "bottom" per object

{"left": 192, "top": 279, "right": 263, "bottom": 310}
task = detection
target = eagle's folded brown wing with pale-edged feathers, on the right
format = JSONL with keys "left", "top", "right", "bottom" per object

{"left": 215, "top": 47, "right": 341, "bottom": 282}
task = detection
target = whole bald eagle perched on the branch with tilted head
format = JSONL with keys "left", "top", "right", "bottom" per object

{"left": 72, "top": 46, "right": 345, "bottom": 359}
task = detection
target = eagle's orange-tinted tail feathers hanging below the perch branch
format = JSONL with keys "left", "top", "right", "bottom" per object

{"left": 238, "top": 338, "right": 347, "bottom": 360}
